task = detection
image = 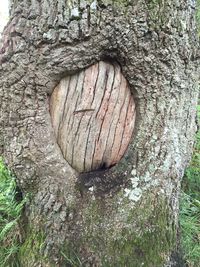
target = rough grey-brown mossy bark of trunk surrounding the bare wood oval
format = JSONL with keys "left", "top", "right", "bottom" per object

{"left": 0, "top": 0, "right": 198, "bottom": 267}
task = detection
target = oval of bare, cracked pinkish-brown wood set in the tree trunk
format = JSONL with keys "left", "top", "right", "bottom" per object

{"left": 50, "top": 61, "right": 135, "bottom": 172}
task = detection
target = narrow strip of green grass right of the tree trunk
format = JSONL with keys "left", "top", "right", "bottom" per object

{"left": 180, "top": 105, "right": 200, "bottom": 267}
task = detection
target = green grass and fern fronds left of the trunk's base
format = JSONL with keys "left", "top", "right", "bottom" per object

{"left": 0, "top": 159, "right": 25, "bottom": 267}
